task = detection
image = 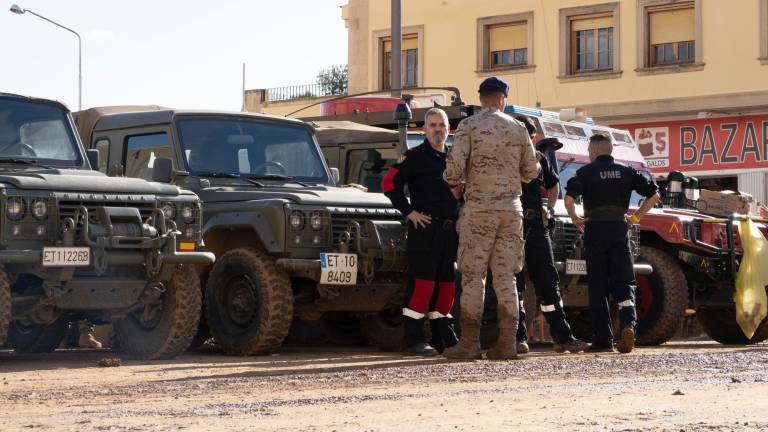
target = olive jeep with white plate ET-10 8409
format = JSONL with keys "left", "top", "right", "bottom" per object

{"left": 76, "top": 107, "right": 406, "bottom": 355}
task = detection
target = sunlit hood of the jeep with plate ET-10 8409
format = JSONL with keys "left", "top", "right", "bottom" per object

{"left": 198, "top": 186, "right": 392, "bottom": 208}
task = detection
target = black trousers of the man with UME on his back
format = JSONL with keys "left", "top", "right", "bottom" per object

{"left": 584, "top": 220, "right": 637, "bottom": 347}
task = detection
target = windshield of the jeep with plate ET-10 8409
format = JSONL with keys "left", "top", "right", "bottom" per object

{"left": 178, "top": 116, "right": 329, "bottom": 184}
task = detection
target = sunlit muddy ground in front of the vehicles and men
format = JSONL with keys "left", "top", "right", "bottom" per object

{"left": 0, "top": 342, "right": 768, "bottom": 431}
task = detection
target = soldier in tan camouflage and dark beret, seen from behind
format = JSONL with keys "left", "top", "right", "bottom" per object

{"left": 443, "top": 77, "right": 539, "bottom": 359}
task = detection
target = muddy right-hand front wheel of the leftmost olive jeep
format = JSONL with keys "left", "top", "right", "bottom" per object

{"left": 113, "top": 265, "right": 202, "bottom": 359}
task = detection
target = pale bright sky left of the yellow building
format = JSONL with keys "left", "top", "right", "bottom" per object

{"left": 0, "top": 0, "right": 347, "bottom": 111}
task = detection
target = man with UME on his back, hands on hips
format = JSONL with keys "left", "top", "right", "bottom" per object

{"left": 565, "top": 135, "right": 659, "bottom": 353}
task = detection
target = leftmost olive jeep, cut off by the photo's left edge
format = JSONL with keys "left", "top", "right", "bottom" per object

{"left": 0, "top": 93, "right": 214, "bottom": 359}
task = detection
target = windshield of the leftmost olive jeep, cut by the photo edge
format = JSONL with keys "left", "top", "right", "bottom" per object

{"left": 0, "top": 98, "right": 82, "bottom": 167}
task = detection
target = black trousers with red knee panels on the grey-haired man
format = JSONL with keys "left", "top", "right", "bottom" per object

{"left": 403, "top": 216, "right": 459, "bottom": 352}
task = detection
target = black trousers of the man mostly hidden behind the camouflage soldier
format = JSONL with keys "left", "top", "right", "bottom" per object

{"left": 515, "top": 207, "right": 574, "bottom": 343}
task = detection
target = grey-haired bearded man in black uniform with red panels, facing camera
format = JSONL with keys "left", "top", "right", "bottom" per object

{"left": 381, "top": 108, "right": 463, "bottom": 355}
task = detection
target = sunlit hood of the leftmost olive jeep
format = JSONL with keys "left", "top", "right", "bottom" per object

{"left": 0, "top": 169, "right": 179, "bottom": 196}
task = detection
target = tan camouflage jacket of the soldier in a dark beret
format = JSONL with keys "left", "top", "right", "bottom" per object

{"left": 443, "top": 109, "right": 538, "bottom": 212}
